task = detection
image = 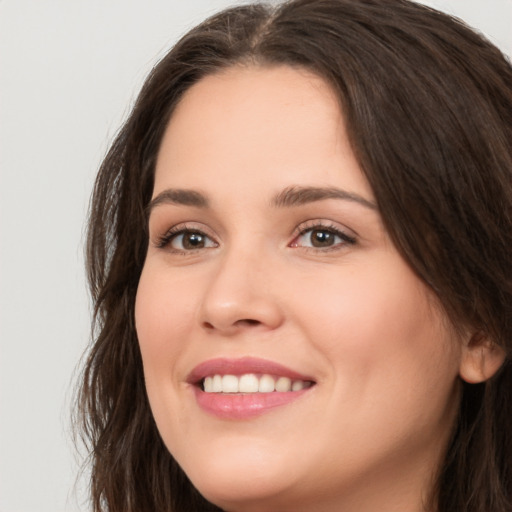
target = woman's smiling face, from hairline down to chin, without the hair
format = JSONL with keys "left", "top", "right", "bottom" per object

{"left": 135, "top": 67, "right": 460, "bottom": 512}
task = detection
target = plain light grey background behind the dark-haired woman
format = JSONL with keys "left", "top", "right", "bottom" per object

{"left": 0, "top": 0, "right": 512, "bottom": 512}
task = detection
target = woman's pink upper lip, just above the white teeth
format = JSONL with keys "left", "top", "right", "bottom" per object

{"left": 187, "top": 357, "right": 314, "bottom": 384}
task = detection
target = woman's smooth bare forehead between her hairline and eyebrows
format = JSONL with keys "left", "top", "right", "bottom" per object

{"left": 155, "top": 66, "right": 372, "bottom": 203}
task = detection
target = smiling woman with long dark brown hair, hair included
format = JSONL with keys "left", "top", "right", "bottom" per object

{"left": 76, "top": 0, "right": 512, "bottom": 512}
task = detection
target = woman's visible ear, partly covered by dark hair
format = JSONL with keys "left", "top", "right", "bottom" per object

{"left": 459, "top": 332, "right": 505, "bottom": 384}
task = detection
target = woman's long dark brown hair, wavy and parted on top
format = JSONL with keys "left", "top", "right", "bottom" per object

{"left": 79, "top": 0, "right": 512, "bottom": 512}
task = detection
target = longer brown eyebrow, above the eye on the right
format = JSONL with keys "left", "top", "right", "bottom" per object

{"left": 271, "top": 186, "right": 377, "bottom": 210}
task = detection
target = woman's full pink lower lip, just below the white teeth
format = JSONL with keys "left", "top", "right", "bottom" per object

{"left": 194, "top": 386, "right": 312, "bottom": 419}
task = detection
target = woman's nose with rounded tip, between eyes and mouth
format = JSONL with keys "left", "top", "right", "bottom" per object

{"left": 200, "top": 245, "right": 283, "bottom": 336}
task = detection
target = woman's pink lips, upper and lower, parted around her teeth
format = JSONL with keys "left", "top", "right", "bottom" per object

{"left": 187, "top": 357, "right": 313, "bottom": 420}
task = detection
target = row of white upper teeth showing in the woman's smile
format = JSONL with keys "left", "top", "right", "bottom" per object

{"left": 203, "top": 373, "right": 311, "bottom": 393}
